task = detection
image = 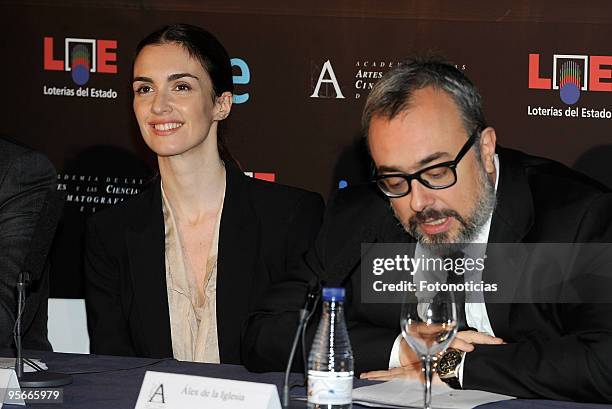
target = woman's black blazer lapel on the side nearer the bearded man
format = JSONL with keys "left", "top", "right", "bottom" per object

{"left": 217, "top": 164, "right": 263, "bottom": 363}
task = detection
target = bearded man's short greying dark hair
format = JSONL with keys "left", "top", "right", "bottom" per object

{"left": 361, "top": 57, "right": 487, "bottom": 146}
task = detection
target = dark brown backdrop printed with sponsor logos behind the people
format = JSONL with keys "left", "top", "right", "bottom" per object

{"left": 0, "top": 0, "right": 612, "bottom": 298}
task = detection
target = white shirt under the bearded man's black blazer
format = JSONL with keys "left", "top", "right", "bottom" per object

{"left": 389, "top": 154, "right": 500, "bottom": 385}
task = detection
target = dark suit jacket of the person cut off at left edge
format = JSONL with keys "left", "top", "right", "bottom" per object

{"left": 0, "top": 138, "right": 56, "bottom": 350}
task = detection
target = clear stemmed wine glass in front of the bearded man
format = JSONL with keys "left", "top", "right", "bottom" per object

{"left": 400, "top": 291, "right": 457, "bottom": 409}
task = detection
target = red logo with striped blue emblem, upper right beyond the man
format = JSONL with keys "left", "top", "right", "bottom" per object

{"left": 529, "top": 54, "right": 612, "bottom": 105}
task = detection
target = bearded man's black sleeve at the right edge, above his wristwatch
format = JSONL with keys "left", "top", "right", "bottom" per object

{"left": 463, "top": 194, "right": 612, "bottom": 402}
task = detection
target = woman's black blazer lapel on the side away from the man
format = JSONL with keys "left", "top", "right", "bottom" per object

{"left": 126, "top": 178, "right": 173, "bottom": 358}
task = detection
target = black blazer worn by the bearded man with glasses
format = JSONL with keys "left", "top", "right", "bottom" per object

{"left": 245, "top": 148, "right": 612, "bottom": 402}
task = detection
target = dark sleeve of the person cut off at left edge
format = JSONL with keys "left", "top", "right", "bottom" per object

{"left": 0, "top": 151, "right": 56, "bottom": 347}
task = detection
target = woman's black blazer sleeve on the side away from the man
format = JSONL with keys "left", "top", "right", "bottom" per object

{"left": 84, "top": 217, "right": 136, "bottom": 356}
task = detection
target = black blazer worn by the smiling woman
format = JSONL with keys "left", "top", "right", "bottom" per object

{"left": 85, "top": 165, "right": 323, "bottom": 364}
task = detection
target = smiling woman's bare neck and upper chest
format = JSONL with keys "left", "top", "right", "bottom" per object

{"left": 158, "top": 142, "right": 225, "bottom": 224}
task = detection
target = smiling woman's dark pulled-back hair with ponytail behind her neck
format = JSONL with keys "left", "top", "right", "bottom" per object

{"left": 134, "top": 24, "right": 234, "bottom": 161}
